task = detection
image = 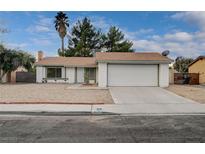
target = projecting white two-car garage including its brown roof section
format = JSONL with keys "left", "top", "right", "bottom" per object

{"left": 96, "top": 52, "right": 171, "bottom": 87}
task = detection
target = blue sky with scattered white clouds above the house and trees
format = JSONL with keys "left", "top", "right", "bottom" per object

{"left": 0, "top": 11, "right": 205, "bottom": 58}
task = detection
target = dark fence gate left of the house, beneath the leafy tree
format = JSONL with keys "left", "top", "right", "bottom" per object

{"left": 16, "top": 72, "right": 36, "bottom": 83}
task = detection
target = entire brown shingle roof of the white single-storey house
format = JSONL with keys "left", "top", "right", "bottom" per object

{"left": 35, "top": 52, "right": 172, "bottom": 67}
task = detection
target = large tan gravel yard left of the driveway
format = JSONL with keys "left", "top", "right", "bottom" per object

{"left": 0, "top": 84, "right": 113, "bottom": 104}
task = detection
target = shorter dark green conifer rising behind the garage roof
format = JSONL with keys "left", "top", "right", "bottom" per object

{"left": 103, "top": 26, "right": 134, "bottom": 52}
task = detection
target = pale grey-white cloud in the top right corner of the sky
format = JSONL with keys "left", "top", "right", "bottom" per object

{"left": 171, "top": 11, "right": 205, "bottom": 31}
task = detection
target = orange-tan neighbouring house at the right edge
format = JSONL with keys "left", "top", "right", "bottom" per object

{"left": 189, "top": 56, "right": 205, "bottom": 84}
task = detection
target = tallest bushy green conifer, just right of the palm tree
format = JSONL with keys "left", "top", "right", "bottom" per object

{"left": 59, "top": 17, "right": 102, "bottom": 57}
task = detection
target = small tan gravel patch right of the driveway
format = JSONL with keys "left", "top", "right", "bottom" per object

{"left": 166, "top": 85, "right": 205, "bottom": 103}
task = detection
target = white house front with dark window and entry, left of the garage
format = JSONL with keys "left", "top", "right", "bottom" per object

{"left": 36, "top": 66, "right": 98, "bottom": 84}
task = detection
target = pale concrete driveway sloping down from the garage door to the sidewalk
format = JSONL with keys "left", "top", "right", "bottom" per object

{"left": 110, "top": 87, "right": 198, "bottom": 104}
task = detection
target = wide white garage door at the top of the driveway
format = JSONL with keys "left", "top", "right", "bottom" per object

{"left": 108, "top": 64, "right": 158, "bottom": 86}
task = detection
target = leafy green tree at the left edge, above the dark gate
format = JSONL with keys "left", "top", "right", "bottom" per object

{"left": 0, "top": 45, "right": 35, "bottom": 82}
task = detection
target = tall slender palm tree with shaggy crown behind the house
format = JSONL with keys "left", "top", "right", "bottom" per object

{"left": 54, "top": 11, "right": 69, "bottom": 55}
